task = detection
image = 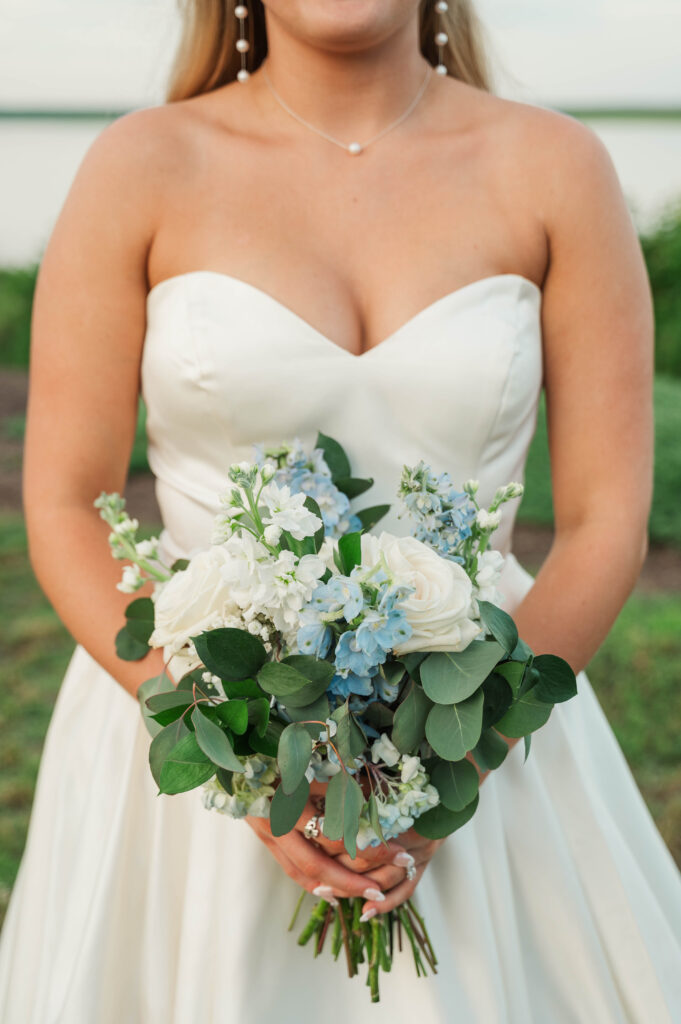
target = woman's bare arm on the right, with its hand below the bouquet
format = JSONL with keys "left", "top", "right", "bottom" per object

{"left": 360, "top": 111, "right": 654, "bottom": 910}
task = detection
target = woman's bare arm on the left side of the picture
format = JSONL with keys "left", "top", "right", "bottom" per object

{"left": 24, "top": 112, "right": 168, "bottom": 696}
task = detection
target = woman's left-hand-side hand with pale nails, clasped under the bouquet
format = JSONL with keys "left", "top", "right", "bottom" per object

{"left": 245, "top": 801, "right": 406, "bottom": 906}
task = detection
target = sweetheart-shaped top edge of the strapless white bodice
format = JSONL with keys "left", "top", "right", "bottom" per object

{"left": 146, "top": 269, "right": 544, "bottom": 359}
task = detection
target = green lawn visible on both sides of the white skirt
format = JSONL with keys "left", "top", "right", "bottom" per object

{"left": 0, "top": 516, "right": 681, "bottom": 933}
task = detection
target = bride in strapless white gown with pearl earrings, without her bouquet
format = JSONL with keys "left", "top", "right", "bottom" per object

{"left": 0, "top": 0, "right": 681, "bottom": 1024}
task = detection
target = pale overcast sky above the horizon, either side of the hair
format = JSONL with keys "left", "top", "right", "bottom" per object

{"left": 0, "top": 0, "right": 681, "bottom": 108}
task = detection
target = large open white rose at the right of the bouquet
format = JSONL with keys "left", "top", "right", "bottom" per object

{"left": 361, "top": 532, "right": 481, "bottom": 654}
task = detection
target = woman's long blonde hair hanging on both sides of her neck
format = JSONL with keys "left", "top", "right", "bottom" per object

{"left": 166, "top": 0, "right": 492, "bottom": 102}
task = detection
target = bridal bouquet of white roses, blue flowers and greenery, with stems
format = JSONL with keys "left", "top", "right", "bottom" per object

{"left": 95, "top": 434, "right": 577, "bottom": 1001}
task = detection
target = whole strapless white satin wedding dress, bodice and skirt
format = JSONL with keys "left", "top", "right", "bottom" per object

{"left": 0, "top": 270, "right": 681, "bottom": 1024}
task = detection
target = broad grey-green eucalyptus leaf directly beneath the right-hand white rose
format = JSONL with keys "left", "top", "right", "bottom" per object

{"left": 421, "top": 640, "right": 504, "bottom": 705}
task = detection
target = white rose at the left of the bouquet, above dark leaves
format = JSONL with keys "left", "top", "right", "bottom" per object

{"left": 150, "top": 546, "right": 239, "bottom": 653}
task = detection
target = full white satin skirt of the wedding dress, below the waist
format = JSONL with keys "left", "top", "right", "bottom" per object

{"left": 0, "top": 556, "right": 681, "bottom": 1024}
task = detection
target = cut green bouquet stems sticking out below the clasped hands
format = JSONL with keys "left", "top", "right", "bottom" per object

{"left": 289, "top": 890, "right": 437, "bottom": 1002}
